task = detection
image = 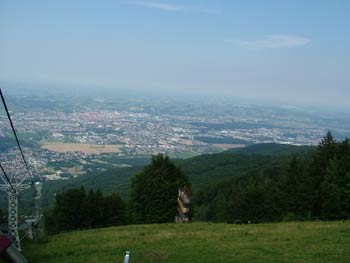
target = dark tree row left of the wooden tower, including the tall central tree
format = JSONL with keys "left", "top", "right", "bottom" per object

{"left": 45, "top": 154, "right": 189, "bottom": 233}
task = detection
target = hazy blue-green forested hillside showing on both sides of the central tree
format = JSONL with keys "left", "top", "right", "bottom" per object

{"left": 42, "top": 144, "right": 313, "bottom": 207}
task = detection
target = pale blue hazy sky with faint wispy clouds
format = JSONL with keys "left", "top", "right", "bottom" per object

{"left": 0, "top": 0, "right": 350, "bottom": 106}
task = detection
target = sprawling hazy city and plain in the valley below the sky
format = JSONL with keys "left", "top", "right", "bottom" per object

{"left": 0, "top": 87, "right": 350, "bottom": 183}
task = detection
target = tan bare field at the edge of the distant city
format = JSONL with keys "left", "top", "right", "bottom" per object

{"left": 41, "top": 142, "right": 120, "bottom": 154}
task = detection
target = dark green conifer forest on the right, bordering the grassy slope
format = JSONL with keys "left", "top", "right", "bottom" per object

{"left": 194, "top": 133, "right": 350, "bottom": 221}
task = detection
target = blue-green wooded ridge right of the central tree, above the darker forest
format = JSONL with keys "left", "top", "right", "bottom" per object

{"left": 177, "top": 143, "right": 315, "bottom": 190}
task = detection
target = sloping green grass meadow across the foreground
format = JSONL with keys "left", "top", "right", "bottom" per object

{"left": 24, "top": 222, "right": 350, "bottom": 263}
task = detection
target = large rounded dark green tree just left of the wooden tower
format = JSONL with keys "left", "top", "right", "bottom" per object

{"left": 130, "top": 155, "right": 189, "bottom": 223}
